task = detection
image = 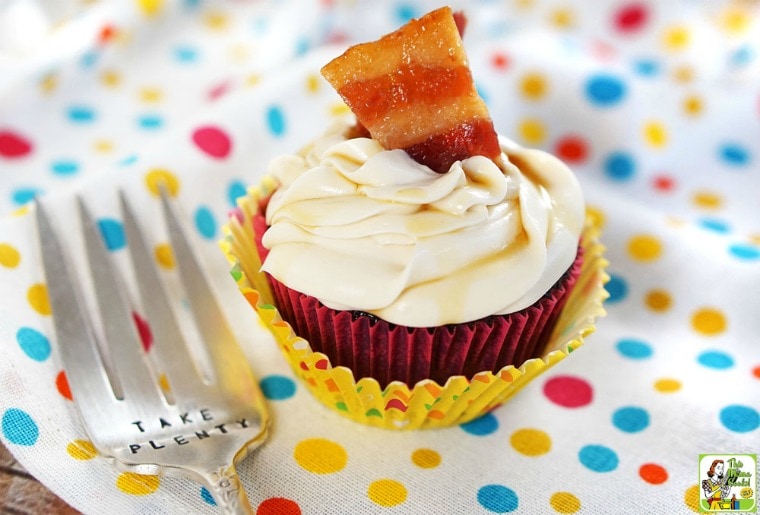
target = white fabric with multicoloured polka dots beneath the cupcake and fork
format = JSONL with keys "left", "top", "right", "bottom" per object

{"left": 0, "top": 0, "right": 760, "bottom": 515}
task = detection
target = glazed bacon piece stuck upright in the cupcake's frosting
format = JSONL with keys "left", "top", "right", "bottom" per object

{"left": 322, "top": 7, "right": 501, "bottom": 173}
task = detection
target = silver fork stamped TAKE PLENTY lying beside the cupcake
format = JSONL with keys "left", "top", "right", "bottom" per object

{"left": 36, "top": 192, "right": 269, "bottom": 513}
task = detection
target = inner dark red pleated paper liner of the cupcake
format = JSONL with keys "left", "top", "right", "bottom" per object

{"left": 253, "top": 214, "right": 583, "bottom": 388}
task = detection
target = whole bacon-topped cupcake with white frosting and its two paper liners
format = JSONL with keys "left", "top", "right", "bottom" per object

{"left": 224, "top": 8, "right": 606, "bottom": 428}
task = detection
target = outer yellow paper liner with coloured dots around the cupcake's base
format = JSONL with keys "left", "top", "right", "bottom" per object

{"left": 221, "top": 178, "right": 609, "bottom": 430}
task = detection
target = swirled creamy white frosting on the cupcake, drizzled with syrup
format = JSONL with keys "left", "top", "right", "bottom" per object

{"left": 262, "top": 121, "right": 584, "bottom": 327}
